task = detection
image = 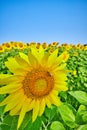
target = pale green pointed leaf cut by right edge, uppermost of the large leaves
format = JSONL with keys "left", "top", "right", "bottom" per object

{"left": 69, "top": 91, "right": 87, "bottom": 105}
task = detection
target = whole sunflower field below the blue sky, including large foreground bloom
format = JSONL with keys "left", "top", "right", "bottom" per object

{"left": 0, "top": 41, "right": 87, "bottom": 130}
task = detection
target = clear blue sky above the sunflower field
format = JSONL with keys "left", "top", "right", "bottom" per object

{"left": 0, "top": 0, "right": 87, "bottom": 44}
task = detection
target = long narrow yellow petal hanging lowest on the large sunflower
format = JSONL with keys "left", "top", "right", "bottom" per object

{"left": 17, "top": 99, "right": 27, "bottom": 129}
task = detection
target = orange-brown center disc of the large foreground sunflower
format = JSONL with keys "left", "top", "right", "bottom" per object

{"left": 23, "top": 69, "right": 54, "bottom": 97}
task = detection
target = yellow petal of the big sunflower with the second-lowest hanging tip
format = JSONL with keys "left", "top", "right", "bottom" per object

{"left": 32, "top": 99, "right": 40, "bottom": 122}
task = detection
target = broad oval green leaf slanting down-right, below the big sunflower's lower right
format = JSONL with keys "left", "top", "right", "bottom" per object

{"left": 58, "top": 104, "right": 76, "bottom": 128}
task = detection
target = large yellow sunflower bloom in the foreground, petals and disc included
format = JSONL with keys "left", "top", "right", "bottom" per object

{"left": 0, "top": 46, "right": 69, "bottom": 129}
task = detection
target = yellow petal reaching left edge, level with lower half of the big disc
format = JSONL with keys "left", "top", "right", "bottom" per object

{"left": 0, "top": 84, "right": 22, "bottom": 94}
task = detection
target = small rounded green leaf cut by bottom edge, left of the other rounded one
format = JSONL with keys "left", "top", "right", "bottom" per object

{"left": 50, "top": 121, "right": 65, "bottom": 130}
